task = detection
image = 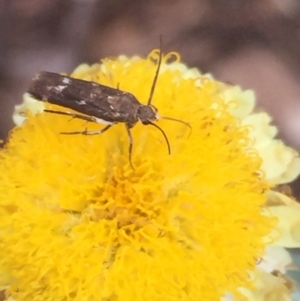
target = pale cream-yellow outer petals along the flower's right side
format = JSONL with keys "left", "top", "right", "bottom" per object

{"left": 218, "top": 86, "right": 300, "bottom": 301}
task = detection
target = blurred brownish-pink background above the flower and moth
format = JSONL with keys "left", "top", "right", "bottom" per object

{"left": 0, "top": 0, "right": 300, "bottom": 300}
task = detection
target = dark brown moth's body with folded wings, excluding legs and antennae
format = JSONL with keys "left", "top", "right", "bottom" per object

{"left": 28, "top": 71, "right": 156, "bottom": 128}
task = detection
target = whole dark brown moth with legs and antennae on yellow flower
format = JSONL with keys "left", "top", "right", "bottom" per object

{"left": 28, "top": 40, "right": 191, "bottom": 169}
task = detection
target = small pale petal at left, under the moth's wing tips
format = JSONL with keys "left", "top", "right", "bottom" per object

{"left": 12, "top": 93, "right": 45, "bottom": 125}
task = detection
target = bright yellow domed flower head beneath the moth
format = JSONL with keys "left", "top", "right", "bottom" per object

{"left": 0, "top": 51, "right": 274, "bottom": 301}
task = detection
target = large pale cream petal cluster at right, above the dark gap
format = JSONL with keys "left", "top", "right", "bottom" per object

{"left": 242, "top": 113, "right": 300, "bottom": 184}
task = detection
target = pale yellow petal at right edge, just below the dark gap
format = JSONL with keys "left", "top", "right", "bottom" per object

{"left": 267, "top": 191, "right": 300, "bottom": 248}
